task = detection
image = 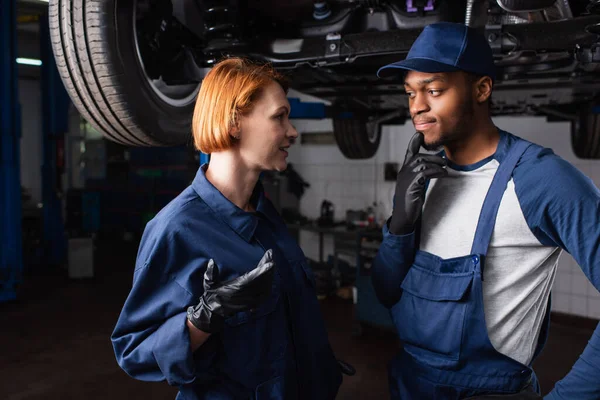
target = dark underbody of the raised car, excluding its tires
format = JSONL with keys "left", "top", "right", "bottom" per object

{"left": 157, "top": 0, "right": 600, "bottom": 119}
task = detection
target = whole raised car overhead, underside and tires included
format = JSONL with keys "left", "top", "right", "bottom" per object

{"left": 50, "top": 0, "right": 600, "bottom": 158}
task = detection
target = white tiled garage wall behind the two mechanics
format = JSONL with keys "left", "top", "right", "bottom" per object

{"left": 289, "top": 117, "right": 600, "bottom": 319}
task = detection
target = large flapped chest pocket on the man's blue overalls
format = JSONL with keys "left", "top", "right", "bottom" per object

{"left": 392, "top": 265, "right": 473, "bottom": 368}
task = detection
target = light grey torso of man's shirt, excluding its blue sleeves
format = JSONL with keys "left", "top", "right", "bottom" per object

{"left": 420, "top": 159, "right": 561, "bottom": 365}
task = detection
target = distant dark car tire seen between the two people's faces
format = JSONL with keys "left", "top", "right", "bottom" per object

{"left": 333, "top": 118, "right": 381, "bottom": 159}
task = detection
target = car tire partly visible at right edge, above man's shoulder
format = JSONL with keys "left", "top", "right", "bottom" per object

{"left": 571, "top": 105, "right": 600, "bottom": 159}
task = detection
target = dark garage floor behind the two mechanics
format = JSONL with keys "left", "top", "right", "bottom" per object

{"left": 0, "top": 239, "right": 592, "bottom": 400}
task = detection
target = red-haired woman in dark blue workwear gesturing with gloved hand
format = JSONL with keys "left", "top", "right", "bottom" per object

{"left": 111, "top": 58, "right": 342, "bottom": 400}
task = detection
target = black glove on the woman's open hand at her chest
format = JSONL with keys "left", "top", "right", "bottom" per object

{"left": 187, "top": 250, "right": 275, "bottom": 333}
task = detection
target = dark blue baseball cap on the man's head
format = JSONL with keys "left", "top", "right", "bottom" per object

{"left": 377, "top": 22, "right": 496, "bottom": 80}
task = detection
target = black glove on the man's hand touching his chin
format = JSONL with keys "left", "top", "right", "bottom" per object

{"left": 389, "top": 132, "right": 448, "bottom": 235}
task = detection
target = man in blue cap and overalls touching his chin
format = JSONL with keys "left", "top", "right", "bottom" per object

{"left": 372, "top": 22, "right": 600, "bottom": 400}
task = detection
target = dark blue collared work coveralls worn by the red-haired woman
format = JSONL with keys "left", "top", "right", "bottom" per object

{"left": 112, "top": 165, "right": 342, "bottom": 400}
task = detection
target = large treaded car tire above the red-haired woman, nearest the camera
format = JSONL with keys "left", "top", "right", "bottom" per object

{"left": 49, "top": 0, "right": 199, "bottom": 147}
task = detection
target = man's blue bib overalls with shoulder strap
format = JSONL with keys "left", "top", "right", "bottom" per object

{"left": 390, "top": 139, "right": 550, "bottom": 400}
